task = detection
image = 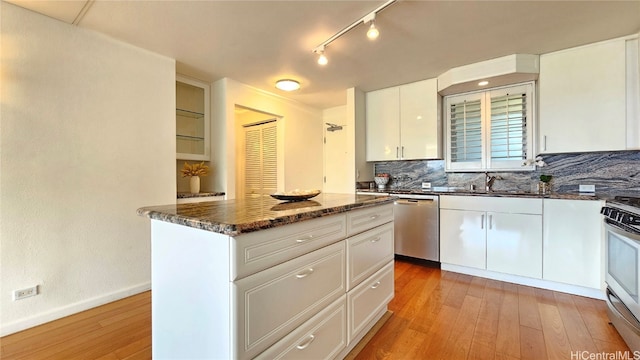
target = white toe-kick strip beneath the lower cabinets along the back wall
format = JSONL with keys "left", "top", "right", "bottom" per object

{"left": 440, "top": 263, "right": 605, "bottom": 300}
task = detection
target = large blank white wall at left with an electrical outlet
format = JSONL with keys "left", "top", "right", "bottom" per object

{"left": 0, "top": 2, "right": 176, "bottom": 335}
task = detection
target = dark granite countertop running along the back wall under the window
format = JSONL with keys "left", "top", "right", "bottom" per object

{"left": 358, "top": 189, "right": 613, "bottom": 200}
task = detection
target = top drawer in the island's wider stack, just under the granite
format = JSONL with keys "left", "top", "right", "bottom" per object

{"left": 230, "top": 214, "right": 347, "bottom": 281}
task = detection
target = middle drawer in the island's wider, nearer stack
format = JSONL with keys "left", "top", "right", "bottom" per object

{"left": 232, "top": 241, "right": 346, "bottom": 359}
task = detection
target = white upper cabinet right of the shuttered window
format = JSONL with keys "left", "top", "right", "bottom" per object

{"left": 539, "top": 39, "right": 638, "bottom": 153}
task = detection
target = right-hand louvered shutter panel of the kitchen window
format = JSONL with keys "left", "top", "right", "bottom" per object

{"left": 487, "top": 85, "right": 533, "bottom": 169}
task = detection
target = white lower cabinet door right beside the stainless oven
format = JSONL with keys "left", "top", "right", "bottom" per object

{"left": 543, "top": 199, "right": 604, "bottom": 289}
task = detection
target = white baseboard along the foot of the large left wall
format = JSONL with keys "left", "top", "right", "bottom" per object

{"left": 0, "top": 282, "right": 151, "bottom": 336}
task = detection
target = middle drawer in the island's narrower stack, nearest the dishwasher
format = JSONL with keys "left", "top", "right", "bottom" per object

{"left": 347, "top": 222, "right": 394, "bottom": 290}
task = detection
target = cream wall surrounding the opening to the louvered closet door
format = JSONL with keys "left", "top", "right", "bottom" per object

{"left": 209, "top": 78, "right": 322, "bottom": 199}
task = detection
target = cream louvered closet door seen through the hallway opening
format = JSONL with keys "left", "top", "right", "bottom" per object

{"left": 244, "top": 121, "right": 278, "bottom": 196}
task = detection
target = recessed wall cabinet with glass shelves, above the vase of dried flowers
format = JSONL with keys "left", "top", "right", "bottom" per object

{"left": 176, "top": 76, "right": 211, "bottom": 161}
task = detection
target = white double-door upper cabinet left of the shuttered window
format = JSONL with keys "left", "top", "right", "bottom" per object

{"left": 366, "top": 79, "right": 442, "bottom": 161}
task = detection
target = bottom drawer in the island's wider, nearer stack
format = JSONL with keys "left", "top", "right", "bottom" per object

{"left": 255, "top": 295, "right": 347, "bottom": 360}
